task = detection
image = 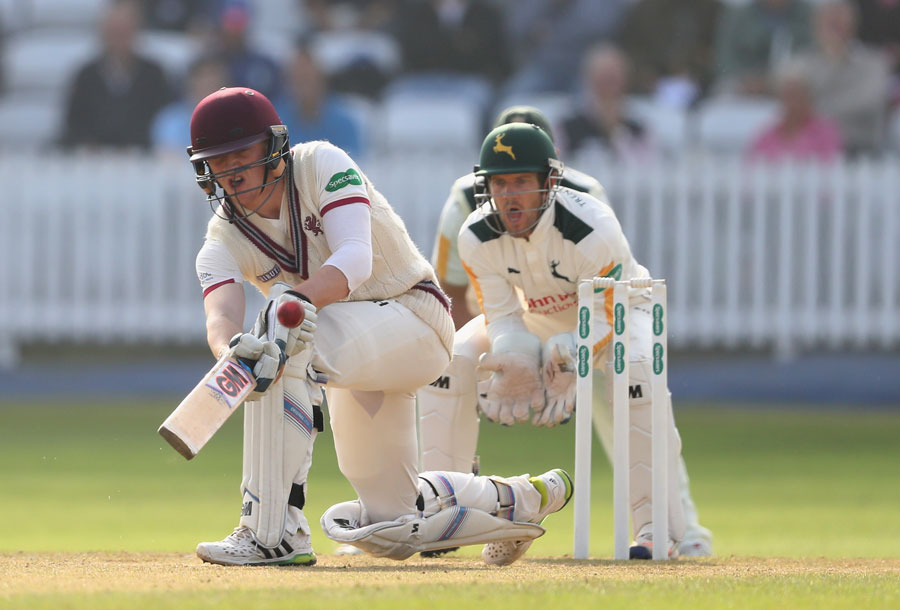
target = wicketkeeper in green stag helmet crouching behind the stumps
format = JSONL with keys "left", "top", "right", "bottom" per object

{"left": 418, "top": 122, "right": 711, "bottom": 559}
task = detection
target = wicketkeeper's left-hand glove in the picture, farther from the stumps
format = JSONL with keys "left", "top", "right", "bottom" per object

{"left": 478, "top": 332, "right": 544, "bottom": 426}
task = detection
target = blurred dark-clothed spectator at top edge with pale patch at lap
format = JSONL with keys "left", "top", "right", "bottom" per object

{"left": 620, "top": 0, "right": 722, "bottom": 107}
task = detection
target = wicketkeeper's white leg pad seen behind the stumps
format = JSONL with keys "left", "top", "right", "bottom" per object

{"left": 629, "top": 360, "right": 684, "bottom": 542}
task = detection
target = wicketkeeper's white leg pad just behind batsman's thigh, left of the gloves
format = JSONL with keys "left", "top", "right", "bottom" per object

{"left": 416, "top": 354, "right": 479, "bottom": 472}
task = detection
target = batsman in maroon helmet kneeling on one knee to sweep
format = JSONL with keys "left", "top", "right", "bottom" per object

{"left": 188, "top": 87, "right": 573, "bottom": 565}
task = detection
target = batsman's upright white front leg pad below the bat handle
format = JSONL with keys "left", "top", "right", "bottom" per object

{"left": 240, "top": 358, "right": 317, "bottom": 547}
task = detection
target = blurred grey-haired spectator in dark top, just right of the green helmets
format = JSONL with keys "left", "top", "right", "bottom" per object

{"left": 559, "top": 45, "right": 654, "bottom": 160}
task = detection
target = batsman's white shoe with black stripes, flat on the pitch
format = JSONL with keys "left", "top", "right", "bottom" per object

{"left": 197, "top": 525, "right": 316, "bottom": 566}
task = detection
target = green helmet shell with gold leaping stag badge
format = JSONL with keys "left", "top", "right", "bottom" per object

{"left": 475, "top": 123, "right": 559, "bottom": 176}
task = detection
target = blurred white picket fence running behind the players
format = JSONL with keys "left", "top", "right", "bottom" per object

{"left": 0, "top": 149, "right": 900, "bottom": 365}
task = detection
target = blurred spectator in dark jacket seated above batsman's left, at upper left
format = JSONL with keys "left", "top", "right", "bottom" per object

{"left": 61, "top": 0, "right": 172, "bottom": 148}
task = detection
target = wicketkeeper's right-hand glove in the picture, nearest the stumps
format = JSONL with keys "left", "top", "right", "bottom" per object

{"left": 531, "top": 333, "right": 576, "bottom": 428}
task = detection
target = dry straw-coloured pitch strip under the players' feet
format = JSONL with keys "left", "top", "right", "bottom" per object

{"left": 0, "top": 553, "right": 900, "bottom": 600}
